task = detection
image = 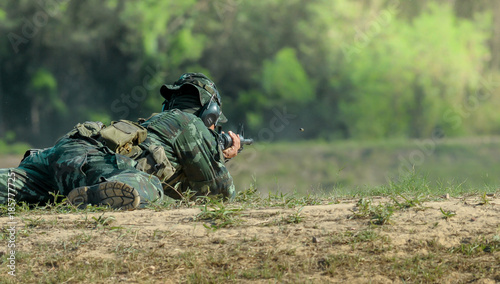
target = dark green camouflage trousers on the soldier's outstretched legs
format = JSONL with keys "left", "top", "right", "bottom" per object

{"left": 0, "top": 137, "right": 163, "bottom": 207}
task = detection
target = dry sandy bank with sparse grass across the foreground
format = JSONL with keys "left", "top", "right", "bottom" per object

{"left": 0, "top": 194, "right": 500, "bottom": 283}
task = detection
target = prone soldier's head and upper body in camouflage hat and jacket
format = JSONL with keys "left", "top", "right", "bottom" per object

{"left": 138, "top": 73, "right": 235, "bottom": 198}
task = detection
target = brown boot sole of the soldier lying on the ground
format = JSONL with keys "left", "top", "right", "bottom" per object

{"left": 67, "top": 181, "right": 141, "bottom": 210}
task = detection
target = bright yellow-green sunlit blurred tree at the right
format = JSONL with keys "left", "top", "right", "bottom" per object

{"left": 341, "top": 4, "right": 488, "bottom": 138}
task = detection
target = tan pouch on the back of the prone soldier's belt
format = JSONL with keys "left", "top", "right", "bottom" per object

{"left": 100, "top": 120, "right": 147, "bottom": 155}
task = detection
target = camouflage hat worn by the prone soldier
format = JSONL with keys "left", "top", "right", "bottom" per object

{"left": 160, "top": 73, "right": 227, "bottom": 123}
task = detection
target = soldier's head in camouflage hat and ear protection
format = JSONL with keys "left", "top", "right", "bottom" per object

{"left": 160, "top": 73, "right": 227, "bottom": 127}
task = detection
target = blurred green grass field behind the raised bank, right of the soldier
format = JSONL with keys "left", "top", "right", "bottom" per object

{"left": 228, "top": 138, "right": 500, "bottom": 196}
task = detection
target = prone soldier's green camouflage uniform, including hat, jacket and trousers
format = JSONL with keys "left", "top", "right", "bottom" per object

{"left": 0, "top": 73, "right": 235, "bottom": 205}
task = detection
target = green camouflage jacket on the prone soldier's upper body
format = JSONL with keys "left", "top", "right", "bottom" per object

{"left": 135, "top": 109, "right": 235, "bottom": 198}
